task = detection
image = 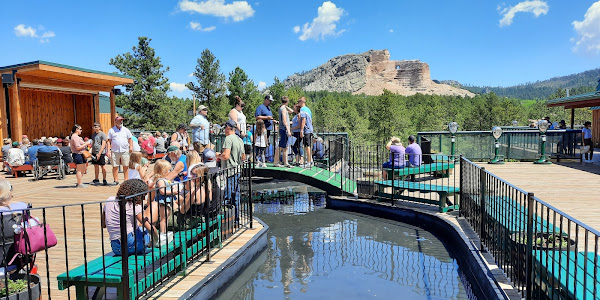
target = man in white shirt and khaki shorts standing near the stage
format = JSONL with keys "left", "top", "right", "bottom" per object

{"left": 106, "top": 116, "right": 133, "bottom": 185}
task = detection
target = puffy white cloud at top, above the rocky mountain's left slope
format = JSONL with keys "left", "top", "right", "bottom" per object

{"left": 294, "top": 1, "right": 345, "bottom": 41}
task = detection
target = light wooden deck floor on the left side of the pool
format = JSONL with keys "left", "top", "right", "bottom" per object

{"left": 0, "top": 165, "right": 262, "bottom": 299}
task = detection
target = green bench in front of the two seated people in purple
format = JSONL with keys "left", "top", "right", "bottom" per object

{"left": 375, "top": 179, "right": 460, "bottom": 212}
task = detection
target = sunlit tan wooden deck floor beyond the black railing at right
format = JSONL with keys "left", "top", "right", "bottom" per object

{"left": 480, "top": 162, "right": 600, "bottom": 234}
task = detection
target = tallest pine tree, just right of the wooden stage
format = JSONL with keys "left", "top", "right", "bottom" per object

{"left": 110, "top": 37, "right": 187, "bottom": 130}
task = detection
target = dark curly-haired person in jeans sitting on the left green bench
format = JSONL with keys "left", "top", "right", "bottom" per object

{"left": 102, "top": 179, "right": 158, "bottom": 255}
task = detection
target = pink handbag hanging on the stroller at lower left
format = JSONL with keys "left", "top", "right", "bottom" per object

{"left": 14, "top": 214, "right": 57, "bottom": 254}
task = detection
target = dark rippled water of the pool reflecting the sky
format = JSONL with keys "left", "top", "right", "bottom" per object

{"left": 217, "top": 185, "right": 474, "bottom": 299}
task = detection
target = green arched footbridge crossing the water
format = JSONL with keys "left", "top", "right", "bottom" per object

{"left": 254, "top": 164, "right": 357, "bottom": 196}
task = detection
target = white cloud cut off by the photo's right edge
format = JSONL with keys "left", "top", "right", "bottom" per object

{"left": 571, "top": 1, "right": 600, "bottom": 54}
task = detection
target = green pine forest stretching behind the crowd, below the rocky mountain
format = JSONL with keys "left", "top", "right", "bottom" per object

{"left": 110, "top": 37, "right": 593, "bottom": 142}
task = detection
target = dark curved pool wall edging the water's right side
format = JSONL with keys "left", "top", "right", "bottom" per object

{"left": 326, "top": 196, "right": 521, "bottom": 299}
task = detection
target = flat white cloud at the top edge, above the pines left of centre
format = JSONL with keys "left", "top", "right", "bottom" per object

{"left": 179, "top": 0, "right": 254, "bottom": 22}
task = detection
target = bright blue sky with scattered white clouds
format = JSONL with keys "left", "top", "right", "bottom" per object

{"left": 0, "top": 0, "right": 600, "bottom": 97}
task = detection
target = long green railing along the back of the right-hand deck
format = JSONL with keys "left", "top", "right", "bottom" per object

{"left": 417, "top": 129, "right": 582, "bottom": 161}
